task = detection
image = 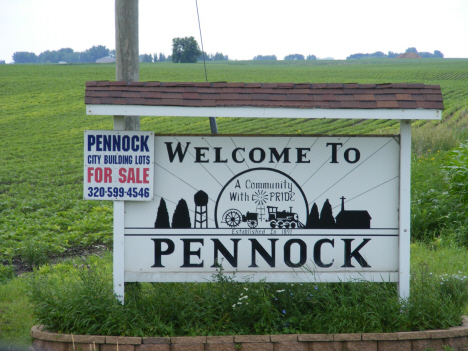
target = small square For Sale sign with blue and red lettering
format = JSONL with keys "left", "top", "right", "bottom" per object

{"left": 83, "top": 130, "right": 154, "bottom": 201}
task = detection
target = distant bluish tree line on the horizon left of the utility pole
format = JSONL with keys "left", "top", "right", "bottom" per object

{"left": 13, "top": 45, "right": 111, "bottom": 63}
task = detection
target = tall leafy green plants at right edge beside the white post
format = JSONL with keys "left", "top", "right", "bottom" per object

{"left": 411, "top": 144, "right": 468, "bottom": 248}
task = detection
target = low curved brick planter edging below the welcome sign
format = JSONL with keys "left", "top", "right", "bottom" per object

{"left": 31, "top": 317, "right": 468, "bottom": 351}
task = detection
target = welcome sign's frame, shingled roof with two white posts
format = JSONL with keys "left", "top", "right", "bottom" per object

{"left": 85, "top": 82, "right": 443, "bottom": 302}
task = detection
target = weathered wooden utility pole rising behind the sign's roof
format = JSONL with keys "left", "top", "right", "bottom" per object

{"left": 114, "top": 0, "right": 140, "bottom": 130}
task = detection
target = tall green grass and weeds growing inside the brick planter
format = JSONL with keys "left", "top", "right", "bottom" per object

{"left": 31, "top": 253, "right": 468, "bottom": 336}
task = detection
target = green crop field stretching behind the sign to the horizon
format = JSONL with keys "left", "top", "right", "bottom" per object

{"left": 0, "top": 59, "right": 468, "bottom": 348}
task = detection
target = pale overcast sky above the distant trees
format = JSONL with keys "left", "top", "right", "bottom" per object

{"left": 0, "top": 0, "right": 468, "bottom": 63}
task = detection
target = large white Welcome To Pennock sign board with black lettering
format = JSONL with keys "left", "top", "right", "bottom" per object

{"left": 124, "top": 135, "right": 400, "bottom": 282}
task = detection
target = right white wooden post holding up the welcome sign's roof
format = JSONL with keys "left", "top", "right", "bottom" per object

{"left": 398, "top": 120, "right": 411, "bottom": 299}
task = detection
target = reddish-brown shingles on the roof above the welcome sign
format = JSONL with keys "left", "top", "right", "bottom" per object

{"left": 85, "top": 81, "right": 444, "bottom": 110}
